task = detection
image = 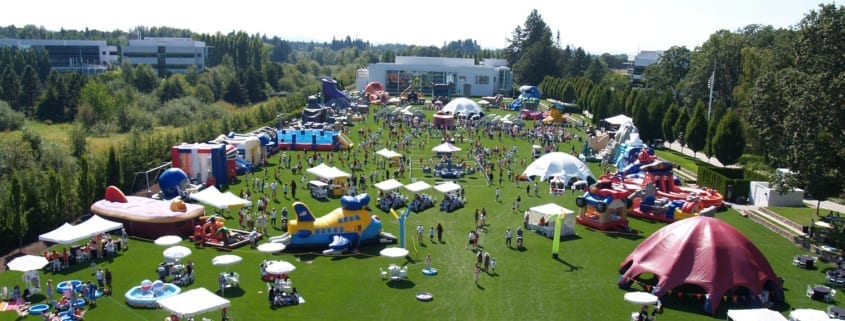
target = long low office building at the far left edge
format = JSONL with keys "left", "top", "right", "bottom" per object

{"left": 0, "top": 38, "right": 118, "bottom": 73}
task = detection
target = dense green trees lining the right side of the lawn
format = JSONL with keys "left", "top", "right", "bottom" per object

{"left": 524, "top": 4, "right": 845, "bottom": 200}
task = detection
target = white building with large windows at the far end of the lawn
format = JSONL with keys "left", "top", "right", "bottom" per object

{"left": 356, "top": 56, "right": 513, "bottom": 97}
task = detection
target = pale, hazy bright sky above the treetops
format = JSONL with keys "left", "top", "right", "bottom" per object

{"left": 0, "top": 0, "right": 819, "bottom": 54}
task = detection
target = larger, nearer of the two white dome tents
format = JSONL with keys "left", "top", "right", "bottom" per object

{"left": 522, "top": 152, "right": 593, "bottom": 182}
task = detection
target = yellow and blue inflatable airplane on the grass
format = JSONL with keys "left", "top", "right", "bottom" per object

{"left": 271, "top": 194, "right": 396, "bottom": 251}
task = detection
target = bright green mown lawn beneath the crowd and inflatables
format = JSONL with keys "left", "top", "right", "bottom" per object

{"left": 0, "top": 108, "right": 832, "bottom": 321}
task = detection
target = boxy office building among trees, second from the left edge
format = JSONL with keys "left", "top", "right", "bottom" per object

{"left": 120, "top": 37, "right": 208, "bottom": 76}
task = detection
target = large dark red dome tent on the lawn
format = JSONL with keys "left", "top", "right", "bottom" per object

{"left": 619, "top": 216, "right": 783, "bottom": 314}
